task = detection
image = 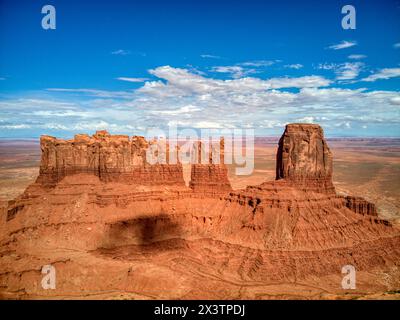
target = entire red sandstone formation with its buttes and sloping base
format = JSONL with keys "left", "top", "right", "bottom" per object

{"left": 0, "top": 124, "right": 400, "bottom": 299}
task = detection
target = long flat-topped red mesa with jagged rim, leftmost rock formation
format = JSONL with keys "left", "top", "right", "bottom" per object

{"left": 37, "top": 130, "right": 185, "bottom": 186}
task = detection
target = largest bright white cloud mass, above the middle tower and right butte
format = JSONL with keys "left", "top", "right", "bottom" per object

{"left": 133, "top": 66, "right": 400, "bottom": 130}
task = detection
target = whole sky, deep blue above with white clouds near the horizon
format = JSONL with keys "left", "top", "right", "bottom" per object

{"left": 0, "top": 0, "right": 400, "bottom": 137}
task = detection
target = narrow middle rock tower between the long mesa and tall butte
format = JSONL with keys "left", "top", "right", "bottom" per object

{"left": 189, "top": 139, "right": 232, "bottom": 193}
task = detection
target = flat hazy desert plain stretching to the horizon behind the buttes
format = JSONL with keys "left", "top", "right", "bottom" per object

{"left": 0, "top": 138, "right": 400, "bottom": 224}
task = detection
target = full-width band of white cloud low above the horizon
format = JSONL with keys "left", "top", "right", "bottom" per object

{"left": 0, "top": 65, "right": 400, "bottom": 135}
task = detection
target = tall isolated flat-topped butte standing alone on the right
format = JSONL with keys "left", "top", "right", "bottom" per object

{"left": 276, "top": 123, "right": 335, "bottom": 194}
